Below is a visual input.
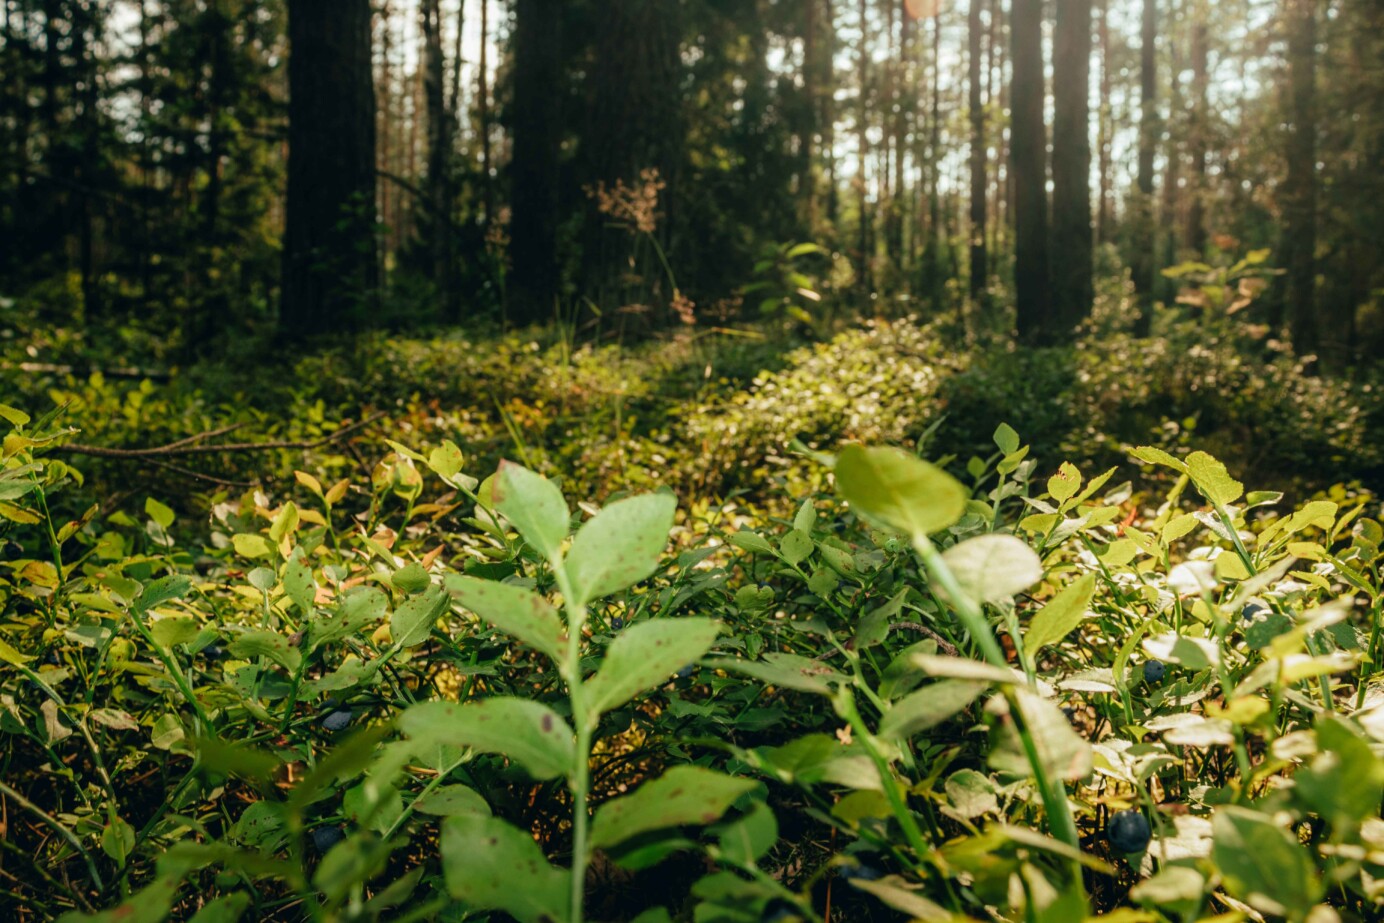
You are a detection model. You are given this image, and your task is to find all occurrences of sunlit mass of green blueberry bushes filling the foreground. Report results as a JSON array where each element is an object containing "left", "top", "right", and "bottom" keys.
[{"left": 0, "top": 398, "right": 1384, "bottom": 923}]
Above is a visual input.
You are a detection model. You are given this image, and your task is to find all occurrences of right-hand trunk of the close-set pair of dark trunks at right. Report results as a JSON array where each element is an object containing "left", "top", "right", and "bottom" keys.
[{"left": 1052, "top": 0, "right": 1092, "bottom": 333}]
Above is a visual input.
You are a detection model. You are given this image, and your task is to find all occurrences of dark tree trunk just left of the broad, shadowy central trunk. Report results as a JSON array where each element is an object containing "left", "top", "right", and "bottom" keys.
[{"left": 507, "top": 0, "right": 563, "bottom": 324}]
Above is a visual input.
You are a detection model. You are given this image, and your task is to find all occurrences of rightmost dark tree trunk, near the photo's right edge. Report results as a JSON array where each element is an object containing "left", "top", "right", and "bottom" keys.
[{"left": 1283, "top": 0, "right": 1322, "bottom": 356}]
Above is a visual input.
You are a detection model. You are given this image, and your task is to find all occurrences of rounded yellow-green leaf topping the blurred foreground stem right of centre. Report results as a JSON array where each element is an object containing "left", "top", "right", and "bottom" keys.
[{"left": 836, "top": 446, "right": 967, "bottom": 537}]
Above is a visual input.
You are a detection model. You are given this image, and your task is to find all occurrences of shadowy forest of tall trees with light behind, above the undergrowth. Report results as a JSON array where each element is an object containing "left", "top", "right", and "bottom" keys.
[{"left": 0, "top": 0, "right": 1384, "bottom": 371}]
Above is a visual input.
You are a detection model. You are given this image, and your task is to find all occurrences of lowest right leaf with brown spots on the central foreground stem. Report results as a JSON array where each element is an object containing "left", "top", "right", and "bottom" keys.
[{"left": 591, "top": 765, "right": 757, "bottom": 848}]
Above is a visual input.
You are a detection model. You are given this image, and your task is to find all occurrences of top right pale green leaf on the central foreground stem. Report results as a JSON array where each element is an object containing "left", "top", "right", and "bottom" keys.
[{"left": 566, "top": 494, "right": 678, "bottom": 606}]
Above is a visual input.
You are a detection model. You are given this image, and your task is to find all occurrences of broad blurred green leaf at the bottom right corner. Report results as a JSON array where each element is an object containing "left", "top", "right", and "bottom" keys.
[{"left": 1211, "top": 805, "right": 1320, "bottom": 920}]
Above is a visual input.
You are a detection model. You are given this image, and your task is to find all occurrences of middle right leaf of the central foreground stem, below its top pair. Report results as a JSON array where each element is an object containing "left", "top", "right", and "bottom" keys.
[{"left": 585, "top": 619, "right": 721, "bottom": 721}]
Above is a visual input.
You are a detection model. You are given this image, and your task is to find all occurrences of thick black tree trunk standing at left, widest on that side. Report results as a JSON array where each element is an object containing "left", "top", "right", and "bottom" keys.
[{"left": 280, "top": 0, "right": 379, "bottom": 338}]
